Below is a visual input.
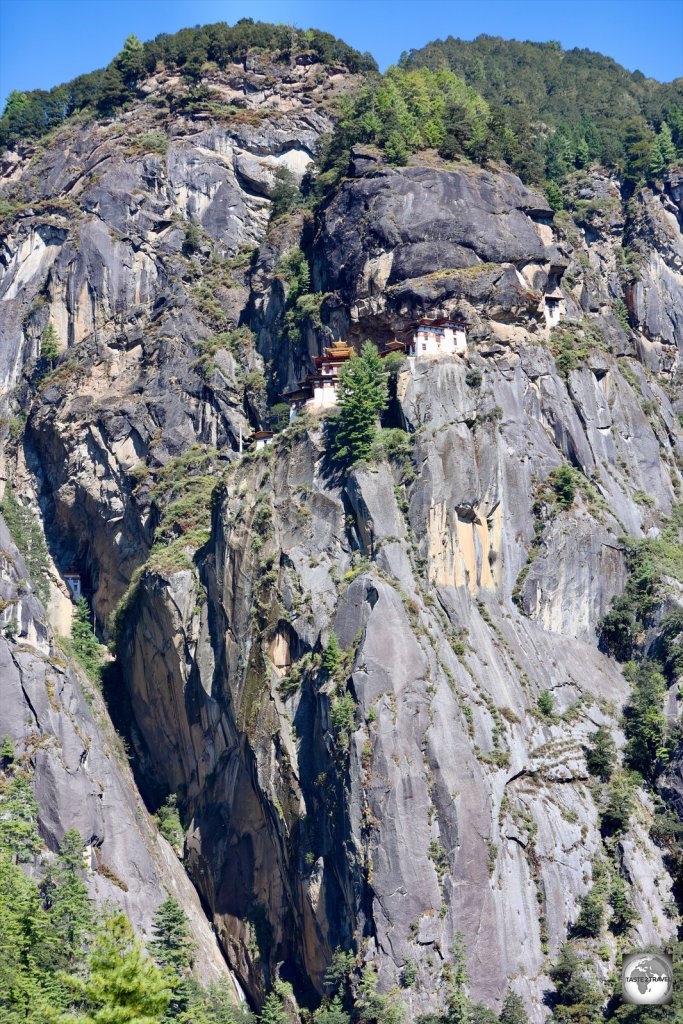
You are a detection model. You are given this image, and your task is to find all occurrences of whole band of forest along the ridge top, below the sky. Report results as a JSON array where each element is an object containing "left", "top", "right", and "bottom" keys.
[{"left": 0, "top": 18, "right": 683, "bottom": 203}]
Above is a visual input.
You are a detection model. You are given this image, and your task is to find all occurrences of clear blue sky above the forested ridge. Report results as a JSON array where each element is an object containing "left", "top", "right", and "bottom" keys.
[{"left": 0, "top": 0, "right": 683, "bottom": 109}]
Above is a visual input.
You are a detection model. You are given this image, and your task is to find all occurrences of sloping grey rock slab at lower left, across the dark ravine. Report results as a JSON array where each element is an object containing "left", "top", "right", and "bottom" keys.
[{"left": 0, "top": 519, "right": 238, "bottom": 1001}]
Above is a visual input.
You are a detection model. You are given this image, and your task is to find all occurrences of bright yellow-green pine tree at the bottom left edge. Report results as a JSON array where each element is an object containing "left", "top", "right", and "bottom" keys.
[{"left": 59, "top": 911, "right": 172, "bottom": 1024}]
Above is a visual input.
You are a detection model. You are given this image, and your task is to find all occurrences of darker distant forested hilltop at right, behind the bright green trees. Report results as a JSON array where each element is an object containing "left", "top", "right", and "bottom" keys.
[{"left": 400, "top": 35, "right": 683, "bottom": 190}]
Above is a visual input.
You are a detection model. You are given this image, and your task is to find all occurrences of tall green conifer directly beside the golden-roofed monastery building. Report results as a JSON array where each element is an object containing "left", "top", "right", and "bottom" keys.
[{"left": 331, "top": 341, "right": 388, "bottom": 466}]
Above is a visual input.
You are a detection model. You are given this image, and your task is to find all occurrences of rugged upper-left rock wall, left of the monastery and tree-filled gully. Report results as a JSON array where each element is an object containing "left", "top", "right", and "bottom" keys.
[{"left": 0, "top": 58, "right": 362, "bottom": 629}]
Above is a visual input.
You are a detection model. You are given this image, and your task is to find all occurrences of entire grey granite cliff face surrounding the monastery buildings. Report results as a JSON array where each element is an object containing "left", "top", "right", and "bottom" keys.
[{"left": 0, "top": 49, "right": 683, "bottom": 1021}]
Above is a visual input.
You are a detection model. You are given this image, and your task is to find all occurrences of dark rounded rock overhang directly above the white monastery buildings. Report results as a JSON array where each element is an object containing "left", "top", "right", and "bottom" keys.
[{"left": 313, "top": 152, "right": 566, "bottom": 350}]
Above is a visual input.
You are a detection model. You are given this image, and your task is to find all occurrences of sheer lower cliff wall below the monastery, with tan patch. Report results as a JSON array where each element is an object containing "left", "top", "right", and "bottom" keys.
[{"left": 120, "top": 350, "right": 673, "bottom": 1019}]
